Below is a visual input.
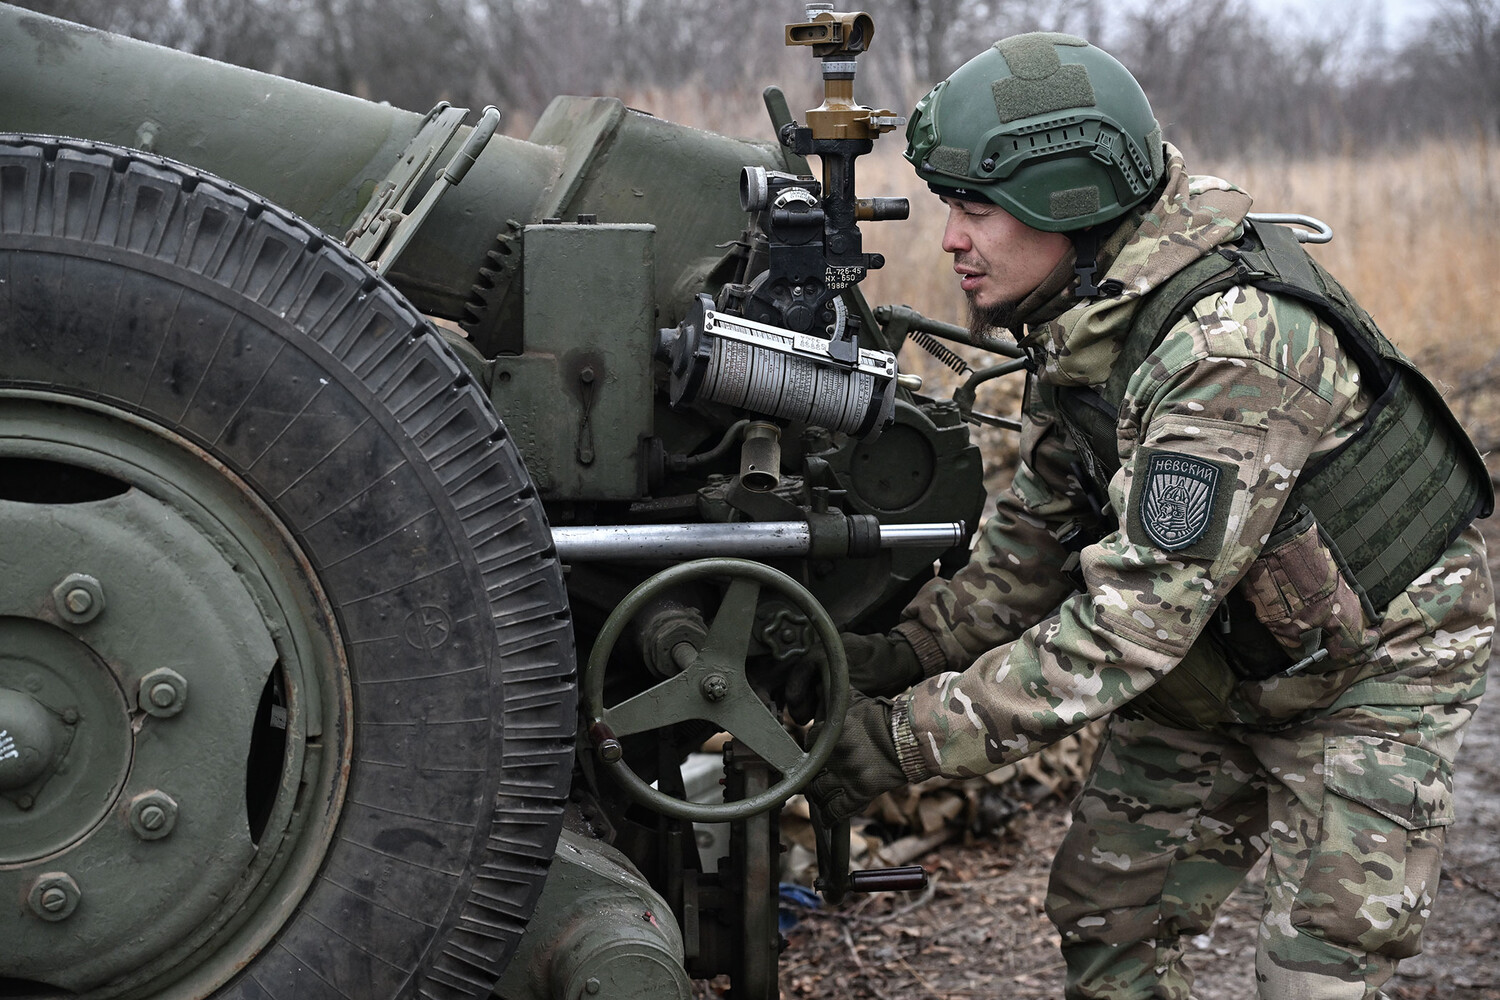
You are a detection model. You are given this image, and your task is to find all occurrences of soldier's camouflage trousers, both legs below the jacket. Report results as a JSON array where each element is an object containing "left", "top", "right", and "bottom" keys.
[{"left": 1047, "top": 702, "right": 1478, "bottom": 1000}]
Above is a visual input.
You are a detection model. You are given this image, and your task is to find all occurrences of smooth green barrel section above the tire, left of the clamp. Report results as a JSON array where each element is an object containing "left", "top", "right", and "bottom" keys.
[{"left": 0, "top": 6, "right": 422, "bottom": 234}]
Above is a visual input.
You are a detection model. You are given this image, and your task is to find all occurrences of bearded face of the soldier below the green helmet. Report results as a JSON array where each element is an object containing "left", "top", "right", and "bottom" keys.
[{"left": 942, "top": 196, "right": 1073, "bottom": 325}]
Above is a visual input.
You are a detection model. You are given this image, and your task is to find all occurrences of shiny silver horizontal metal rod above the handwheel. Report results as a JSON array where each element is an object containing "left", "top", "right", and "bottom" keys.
[{"left": 552, "top": 520, "right": 966, "bottom": 562}]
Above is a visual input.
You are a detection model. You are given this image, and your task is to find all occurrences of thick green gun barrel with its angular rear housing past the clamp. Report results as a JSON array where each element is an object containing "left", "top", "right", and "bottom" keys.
[{"left": 0, "top": 3, "right": 785, "bottom": 324}]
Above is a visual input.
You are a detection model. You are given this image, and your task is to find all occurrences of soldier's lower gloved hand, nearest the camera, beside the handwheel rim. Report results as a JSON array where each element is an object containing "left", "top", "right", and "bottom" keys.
[{"left": 804, "top": 691, "right": 906, "bottom": 825}]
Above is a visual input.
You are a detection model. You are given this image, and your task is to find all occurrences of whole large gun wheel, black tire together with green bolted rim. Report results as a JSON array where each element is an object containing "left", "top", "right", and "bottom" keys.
[{"left": 0, "top": 136, "right": 576, "bottom": 1000}]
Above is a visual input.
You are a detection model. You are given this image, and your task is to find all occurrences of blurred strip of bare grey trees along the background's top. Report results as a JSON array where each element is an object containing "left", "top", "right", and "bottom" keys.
[{"left": 8, "top": 0, "right": 1500, "bottom": 153}]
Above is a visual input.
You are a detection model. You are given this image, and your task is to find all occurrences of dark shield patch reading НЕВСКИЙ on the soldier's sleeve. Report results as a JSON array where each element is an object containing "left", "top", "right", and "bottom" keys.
[{"left": 1128, "top": 448, "right": 1235, "bottom": 555}]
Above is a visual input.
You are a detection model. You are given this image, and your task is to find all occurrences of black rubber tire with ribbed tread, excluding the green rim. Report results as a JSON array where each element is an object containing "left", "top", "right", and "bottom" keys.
[{"left": 0, "top": 135, "right": 576, "bottom": 1000}]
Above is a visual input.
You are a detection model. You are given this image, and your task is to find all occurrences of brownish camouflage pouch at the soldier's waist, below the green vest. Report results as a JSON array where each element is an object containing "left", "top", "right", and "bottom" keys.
[{"left": 1239, "top": 508, "right": 1380, "bottom": 672}]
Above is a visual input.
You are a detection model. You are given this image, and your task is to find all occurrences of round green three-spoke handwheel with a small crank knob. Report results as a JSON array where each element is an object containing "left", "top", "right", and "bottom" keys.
[{"left": 584, "top": 559, "right": 849, "bottom": 823}]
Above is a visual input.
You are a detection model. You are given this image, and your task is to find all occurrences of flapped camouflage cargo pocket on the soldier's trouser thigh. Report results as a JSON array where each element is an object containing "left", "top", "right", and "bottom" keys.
[{"left": 1292, "top": 736, "right": 1454, "bottom": 958}]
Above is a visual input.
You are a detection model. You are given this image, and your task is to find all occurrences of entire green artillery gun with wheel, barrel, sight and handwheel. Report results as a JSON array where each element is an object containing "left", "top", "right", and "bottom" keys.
[{"left": 0, "top": 4, "right": 1020, "bottom": 1000}]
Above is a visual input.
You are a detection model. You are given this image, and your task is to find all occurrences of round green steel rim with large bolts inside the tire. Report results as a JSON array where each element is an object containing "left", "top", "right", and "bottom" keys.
[{"left": 0, "top": 393, "right": 351, "bottom": 1000}]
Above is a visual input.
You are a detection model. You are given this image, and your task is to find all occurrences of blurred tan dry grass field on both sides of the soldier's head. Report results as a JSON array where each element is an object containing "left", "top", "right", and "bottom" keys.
[{"left": 861, "top": 139, "right": 1500, "bottom": 395}]
